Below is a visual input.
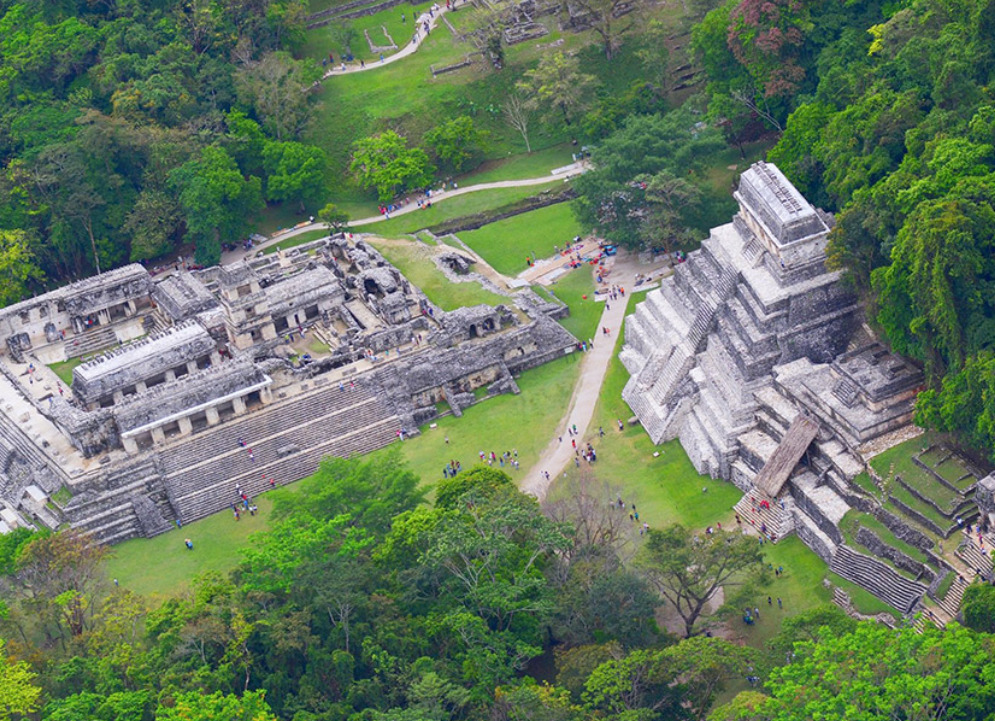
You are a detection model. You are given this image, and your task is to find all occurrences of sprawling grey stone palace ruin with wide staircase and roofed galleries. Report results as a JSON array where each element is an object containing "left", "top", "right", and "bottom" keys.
[{"left": 0, "top": 236, "right": 576, "bottom": 542}]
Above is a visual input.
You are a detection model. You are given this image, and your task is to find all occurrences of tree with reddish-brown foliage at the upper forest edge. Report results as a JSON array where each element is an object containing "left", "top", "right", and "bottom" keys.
[{"left": 727, "top": 0, "right": 810, "bottom": 99}]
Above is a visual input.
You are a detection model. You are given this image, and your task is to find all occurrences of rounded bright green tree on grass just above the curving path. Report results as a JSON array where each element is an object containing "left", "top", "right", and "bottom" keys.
[{"left": 349, "top": 130, "right": 435, "bottom": 202}]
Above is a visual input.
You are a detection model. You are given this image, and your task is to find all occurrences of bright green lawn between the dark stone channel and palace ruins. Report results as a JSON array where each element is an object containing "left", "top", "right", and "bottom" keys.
[{"left": 457, "top": 202, "right": 583, "bottom": 276}]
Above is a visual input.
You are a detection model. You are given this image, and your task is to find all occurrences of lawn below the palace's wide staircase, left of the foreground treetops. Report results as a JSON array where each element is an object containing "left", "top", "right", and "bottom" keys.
[{"left": 106, "top": 493, "right": 273, "bottom": 596}]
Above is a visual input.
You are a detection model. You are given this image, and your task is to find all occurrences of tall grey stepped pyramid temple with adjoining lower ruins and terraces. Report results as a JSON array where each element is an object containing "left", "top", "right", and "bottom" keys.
[{"left": 621, "top": 162, "right": 995, "bottom": 612}]
